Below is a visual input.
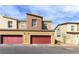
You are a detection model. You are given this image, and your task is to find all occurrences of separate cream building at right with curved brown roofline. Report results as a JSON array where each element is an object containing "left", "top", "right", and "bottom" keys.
[{"left": 54, "top": 22, "right": 79, "bottom": 44}]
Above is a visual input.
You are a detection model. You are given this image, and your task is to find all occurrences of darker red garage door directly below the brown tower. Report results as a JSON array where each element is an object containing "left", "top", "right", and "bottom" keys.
[{"left": 31, "top": 36, "right": 51, "bottom": 44}]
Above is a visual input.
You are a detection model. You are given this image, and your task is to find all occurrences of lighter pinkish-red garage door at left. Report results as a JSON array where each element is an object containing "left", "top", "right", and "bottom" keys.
[{"left": 2, "top": 35, "right": 22, "bottom": 44}]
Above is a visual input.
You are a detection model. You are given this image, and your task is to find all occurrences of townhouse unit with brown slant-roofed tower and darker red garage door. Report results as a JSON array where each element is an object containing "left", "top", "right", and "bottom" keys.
[{"left": 23, "top": 13, "right": 54, "bottom": 44}]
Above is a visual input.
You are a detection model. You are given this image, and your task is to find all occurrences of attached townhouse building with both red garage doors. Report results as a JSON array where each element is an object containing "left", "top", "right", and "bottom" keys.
[{"left": 0, "top": 13, "right": 55, "bottom": 45}]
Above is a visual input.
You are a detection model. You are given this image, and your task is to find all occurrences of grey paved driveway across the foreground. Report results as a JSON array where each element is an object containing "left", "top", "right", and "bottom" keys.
[{"left": 0, "top": 45, "right": 79, "bottom": 54}]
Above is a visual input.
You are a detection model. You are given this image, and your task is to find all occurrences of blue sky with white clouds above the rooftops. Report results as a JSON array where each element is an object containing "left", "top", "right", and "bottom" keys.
[{"left": 0, "top": 5, "right": 79, "bottom": 28}]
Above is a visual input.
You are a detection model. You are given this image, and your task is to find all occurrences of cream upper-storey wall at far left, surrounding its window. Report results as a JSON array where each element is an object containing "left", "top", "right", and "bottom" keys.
[{"left": 0, "top": 16, "right": 17, "bottom": 29}]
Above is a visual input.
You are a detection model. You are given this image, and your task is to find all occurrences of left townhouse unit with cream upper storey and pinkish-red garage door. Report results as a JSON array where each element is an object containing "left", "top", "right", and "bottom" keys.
[{"left": 0, "top": 15, "right": 22, "bottom": 44}]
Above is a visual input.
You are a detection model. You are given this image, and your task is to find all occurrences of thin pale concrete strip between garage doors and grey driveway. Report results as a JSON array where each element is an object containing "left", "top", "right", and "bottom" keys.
[{"left": 0, "top": 44, "right": 79, "bottom": 48}]
